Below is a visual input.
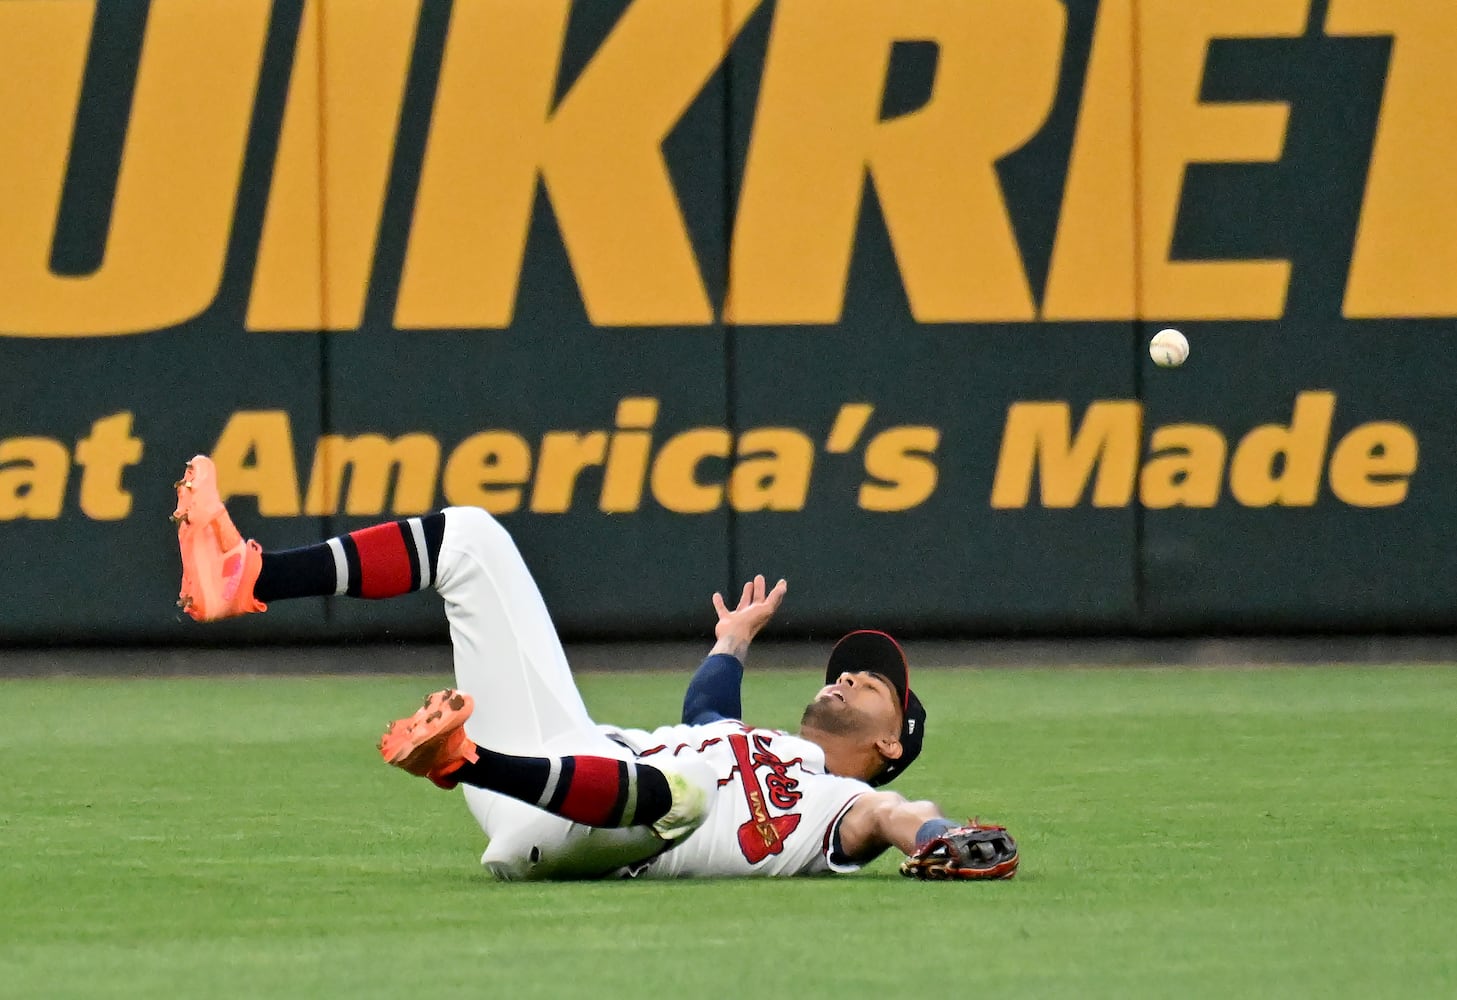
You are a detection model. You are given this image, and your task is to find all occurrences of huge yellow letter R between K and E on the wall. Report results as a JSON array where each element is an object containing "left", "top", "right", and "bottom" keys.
[{"left": 724, "top": 0, "right": 1067, "bottom": 324}]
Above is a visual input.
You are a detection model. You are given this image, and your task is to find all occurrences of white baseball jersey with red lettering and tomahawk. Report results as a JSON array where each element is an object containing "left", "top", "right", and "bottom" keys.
[{"left": 606, "top": 720, "right": 871, "bottom": 879}]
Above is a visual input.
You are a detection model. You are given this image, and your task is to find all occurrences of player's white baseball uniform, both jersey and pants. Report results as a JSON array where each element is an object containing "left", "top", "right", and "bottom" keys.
[{"left": 422, "top": 507, "right": 870, "bottom": 879}]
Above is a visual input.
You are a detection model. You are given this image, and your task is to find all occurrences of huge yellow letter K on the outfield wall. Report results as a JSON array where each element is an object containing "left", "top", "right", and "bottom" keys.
[{"left": 395, "top": 0, "right": 759, "bottom": 329}]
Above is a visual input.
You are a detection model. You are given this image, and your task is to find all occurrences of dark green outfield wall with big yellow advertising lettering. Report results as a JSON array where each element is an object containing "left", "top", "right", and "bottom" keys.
[{"left": 0, "top": 0, "right": 1457, "bottom": 643}]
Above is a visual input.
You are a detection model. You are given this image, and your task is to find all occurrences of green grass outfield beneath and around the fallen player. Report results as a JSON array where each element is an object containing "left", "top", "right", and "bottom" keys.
[{"left": 0, "top": 668, "right": 1457, "bottom": 999}]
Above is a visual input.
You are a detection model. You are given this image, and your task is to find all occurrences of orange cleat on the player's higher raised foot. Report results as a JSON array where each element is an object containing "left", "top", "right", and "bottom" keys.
[{"left": 172, "top": 455, "right": 268, "bottom": 621}]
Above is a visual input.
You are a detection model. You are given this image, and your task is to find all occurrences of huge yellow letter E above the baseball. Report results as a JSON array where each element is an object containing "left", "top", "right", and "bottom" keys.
[{"left": 1043, "top": 0, "right": 1310, "bottom": 319}]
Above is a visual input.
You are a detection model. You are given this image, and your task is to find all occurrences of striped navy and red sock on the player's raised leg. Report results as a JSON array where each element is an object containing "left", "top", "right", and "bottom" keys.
[{"left": 254, "top": 513, "right": 446, "bottom": 602}]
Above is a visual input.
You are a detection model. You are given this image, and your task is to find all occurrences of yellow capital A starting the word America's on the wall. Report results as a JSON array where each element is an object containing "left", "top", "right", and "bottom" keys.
[{"left": 208, "top": 410, "right": 299, "bottom": 517}]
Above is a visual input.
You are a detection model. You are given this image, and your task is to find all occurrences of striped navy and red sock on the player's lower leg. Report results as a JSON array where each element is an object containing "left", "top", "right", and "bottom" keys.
[{"left": 450, "top": 746, "right": 673, "bottom": 827}]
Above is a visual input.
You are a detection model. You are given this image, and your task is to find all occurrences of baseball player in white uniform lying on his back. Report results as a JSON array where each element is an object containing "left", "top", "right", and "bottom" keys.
[{"left": 173, "top": 455, "right": 1017, "bottom": 879}]
